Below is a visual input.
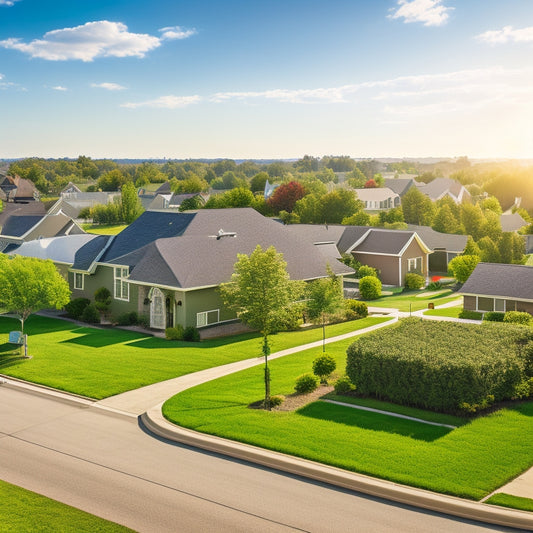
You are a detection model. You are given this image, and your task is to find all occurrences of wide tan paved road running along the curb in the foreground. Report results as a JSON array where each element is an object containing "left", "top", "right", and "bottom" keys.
[{"left": 0, "top": 385, "right": 508, "bottom": 533}]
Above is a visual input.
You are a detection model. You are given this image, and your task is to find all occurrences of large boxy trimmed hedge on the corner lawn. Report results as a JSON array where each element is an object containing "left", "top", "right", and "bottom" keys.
[{"left": 346, "top": 318, "right": 533, "bottom": 413}]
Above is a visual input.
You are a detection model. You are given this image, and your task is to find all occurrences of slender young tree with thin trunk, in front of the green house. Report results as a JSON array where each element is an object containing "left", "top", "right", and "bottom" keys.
[{"left": 219, "top": 245, "right": 303, "bottom": 410}]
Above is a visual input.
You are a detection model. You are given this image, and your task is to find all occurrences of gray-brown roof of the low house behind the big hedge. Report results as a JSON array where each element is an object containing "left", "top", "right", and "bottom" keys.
[{"left": 459, "top": 263, "right": 533, "bottom": 301}]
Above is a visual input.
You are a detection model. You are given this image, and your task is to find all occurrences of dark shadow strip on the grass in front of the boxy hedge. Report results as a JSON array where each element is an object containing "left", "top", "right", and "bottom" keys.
[{"left": 296, "top": 402, "right": 453, "bottom": 442}]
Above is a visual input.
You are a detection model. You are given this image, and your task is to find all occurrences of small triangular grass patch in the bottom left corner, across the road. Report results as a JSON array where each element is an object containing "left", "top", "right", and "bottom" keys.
[{"left": 0, "top": 480, "right": 132, "bottom": 533}]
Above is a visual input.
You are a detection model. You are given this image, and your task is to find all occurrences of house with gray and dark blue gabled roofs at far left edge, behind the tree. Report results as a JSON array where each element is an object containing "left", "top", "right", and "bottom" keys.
[{"left": 0, "top": 202, "right": 85, "bottom": 252}]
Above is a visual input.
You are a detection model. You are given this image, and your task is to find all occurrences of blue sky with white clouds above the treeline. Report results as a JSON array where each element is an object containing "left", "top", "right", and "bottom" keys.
[{"left": 0, "top": 0, "right": 533, "bottom": 159}]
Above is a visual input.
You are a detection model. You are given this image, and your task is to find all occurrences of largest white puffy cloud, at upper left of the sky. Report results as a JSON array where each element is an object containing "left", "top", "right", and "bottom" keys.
[{"left": 0, "top": 20, "right": 194, "bottom": 61}]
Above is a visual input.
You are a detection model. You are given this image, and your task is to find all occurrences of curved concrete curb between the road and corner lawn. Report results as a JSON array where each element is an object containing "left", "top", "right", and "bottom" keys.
[{"left": 140, "top": 403, "right": 533, "bottom": 531}]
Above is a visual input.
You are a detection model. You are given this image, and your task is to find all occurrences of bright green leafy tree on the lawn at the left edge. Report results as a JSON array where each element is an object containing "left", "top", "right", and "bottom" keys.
[{"left": 0, "top": 254, "right": 70, "bottom": 355}]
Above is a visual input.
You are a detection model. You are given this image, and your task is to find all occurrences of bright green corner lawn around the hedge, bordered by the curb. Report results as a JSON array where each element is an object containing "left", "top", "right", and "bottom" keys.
[{"left": 163, "top": 332, "right": 533, "bottom": 499}]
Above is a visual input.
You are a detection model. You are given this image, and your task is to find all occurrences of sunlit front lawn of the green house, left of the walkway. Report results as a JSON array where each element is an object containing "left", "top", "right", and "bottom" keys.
[{"left": 0, "top": 316, "right": 390, "bottom": 399}]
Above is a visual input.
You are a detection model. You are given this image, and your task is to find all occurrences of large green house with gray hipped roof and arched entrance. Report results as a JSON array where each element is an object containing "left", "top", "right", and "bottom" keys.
[{"left": 10, "top": 208, "right": 353, "bottom": 329}]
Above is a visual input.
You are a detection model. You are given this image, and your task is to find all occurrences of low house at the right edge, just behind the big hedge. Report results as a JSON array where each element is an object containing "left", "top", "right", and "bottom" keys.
[{"left": 459, "top": 263, "right": 533, "bottom": 314}]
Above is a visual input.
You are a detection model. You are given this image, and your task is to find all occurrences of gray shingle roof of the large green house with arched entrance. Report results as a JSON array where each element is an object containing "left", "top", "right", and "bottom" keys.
[{"left": 102, "top": 208, "right": 353, "bottom": 289}]
